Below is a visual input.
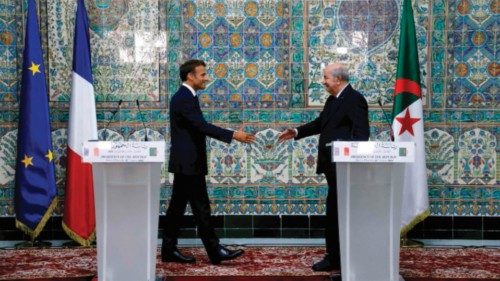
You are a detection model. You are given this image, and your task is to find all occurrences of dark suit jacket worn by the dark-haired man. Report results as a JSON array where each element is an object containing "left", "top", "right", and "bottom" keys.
[{"left": 168, "top": 86, "right": 233, "bottom": 175}]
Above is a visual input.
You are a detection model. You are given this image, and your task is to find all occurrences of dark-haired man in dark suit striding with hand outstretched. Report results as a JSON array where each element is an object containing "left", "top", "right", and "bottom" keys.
[{"left": 161, "top": 60, "right": 255, "bottom": 264}]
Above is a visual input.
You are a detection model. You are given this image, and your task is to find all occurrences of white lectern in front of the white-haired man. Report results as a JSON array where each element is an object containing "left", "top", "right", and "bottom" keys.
[{"left": 331, "top": 142, "right": 415, "bottom": 281}]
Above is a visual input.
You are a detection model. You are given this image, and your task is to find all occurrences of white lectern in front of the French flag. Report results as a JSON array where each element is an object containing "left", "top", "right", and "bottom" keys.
[{"left": 83, "top": 141, "right": 165, "bottom": 281}]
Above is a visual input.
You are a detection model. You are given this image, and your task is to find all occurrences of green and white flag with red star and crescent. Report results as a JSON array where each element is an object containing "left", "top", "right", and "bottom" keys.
[{"left": 392, "top": 0, "right": 429, "bottom": 235}]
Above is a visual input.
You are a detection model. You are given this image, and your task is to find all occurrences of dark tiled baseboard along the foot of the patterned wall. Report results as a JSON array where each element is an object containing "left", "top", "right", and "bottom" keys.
[{"left": 0, "top": 215, "right": 500, "bottom": 240}]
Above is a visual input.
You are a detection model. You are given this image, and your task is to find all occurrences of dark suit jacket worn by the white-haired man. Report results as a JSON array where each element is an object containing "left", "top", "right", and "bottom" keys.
[{"left": 295, "top": 84, "right": 370, "bottom": 174}]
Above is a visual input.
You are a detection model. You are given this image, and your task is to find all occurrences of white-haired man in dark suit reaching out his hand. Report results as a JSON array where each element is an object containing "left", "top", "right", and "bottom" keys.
[{"left": 278, "top": 63, "right": 370, "bottom": 271}]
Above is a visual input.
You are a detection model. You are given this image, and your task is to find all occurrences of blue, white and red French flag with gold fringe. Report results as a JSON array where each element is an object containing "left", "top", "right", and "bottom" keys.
[{"left": 62, "top": 0, "right": 97, "bottom": 246}]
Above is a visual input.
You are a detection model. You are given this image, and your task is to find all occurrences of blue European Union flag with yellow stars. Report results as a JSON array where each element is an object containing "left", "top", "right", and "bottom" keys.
[{"left": 14, "top": 0, "right": 57, "bottom": 241}]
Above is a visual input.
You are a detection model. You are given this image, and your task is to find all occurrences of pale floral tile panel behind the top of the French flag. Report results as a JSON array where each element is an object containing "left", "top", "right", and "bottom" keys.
[{"left": 47, "top": 0, "right": 160, "bottom": 102}]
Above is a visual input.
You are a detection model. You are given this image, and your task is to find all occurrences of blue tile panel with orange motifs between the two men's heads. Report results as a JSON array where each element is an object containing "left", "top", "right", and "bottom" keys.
[{"left": 169, "top": 0, "right": 302, "bottom": 109}]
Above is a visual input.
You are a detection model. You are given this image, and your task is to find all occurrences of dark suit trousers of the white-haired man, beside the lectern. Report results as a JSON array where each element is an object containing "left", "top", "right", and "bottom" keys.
[{"left": 324, "top": 163, "right": 340, "bottom": 261}]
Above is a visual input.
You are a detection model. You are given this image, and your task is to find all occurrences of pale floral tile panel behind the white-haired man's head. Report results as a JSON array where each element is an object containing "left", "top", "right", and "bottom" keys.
[{"left": 306, "top": 0, "right": 431, "bottom": 106}]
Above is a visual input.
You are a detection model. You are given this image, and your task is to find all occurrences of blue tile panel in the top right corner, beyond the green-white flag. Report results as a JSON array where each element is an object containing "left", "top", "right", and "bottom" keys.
[{"left": 446, "top": 1, "right": 499, "bottom": 109}]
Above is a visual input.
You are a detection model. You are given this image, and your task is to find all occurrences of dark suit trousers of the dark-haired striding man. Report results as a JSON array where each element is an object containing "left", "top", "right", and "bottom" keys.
[{"left": 163, "top": 174, "right": 219, "bottom": 252}]
